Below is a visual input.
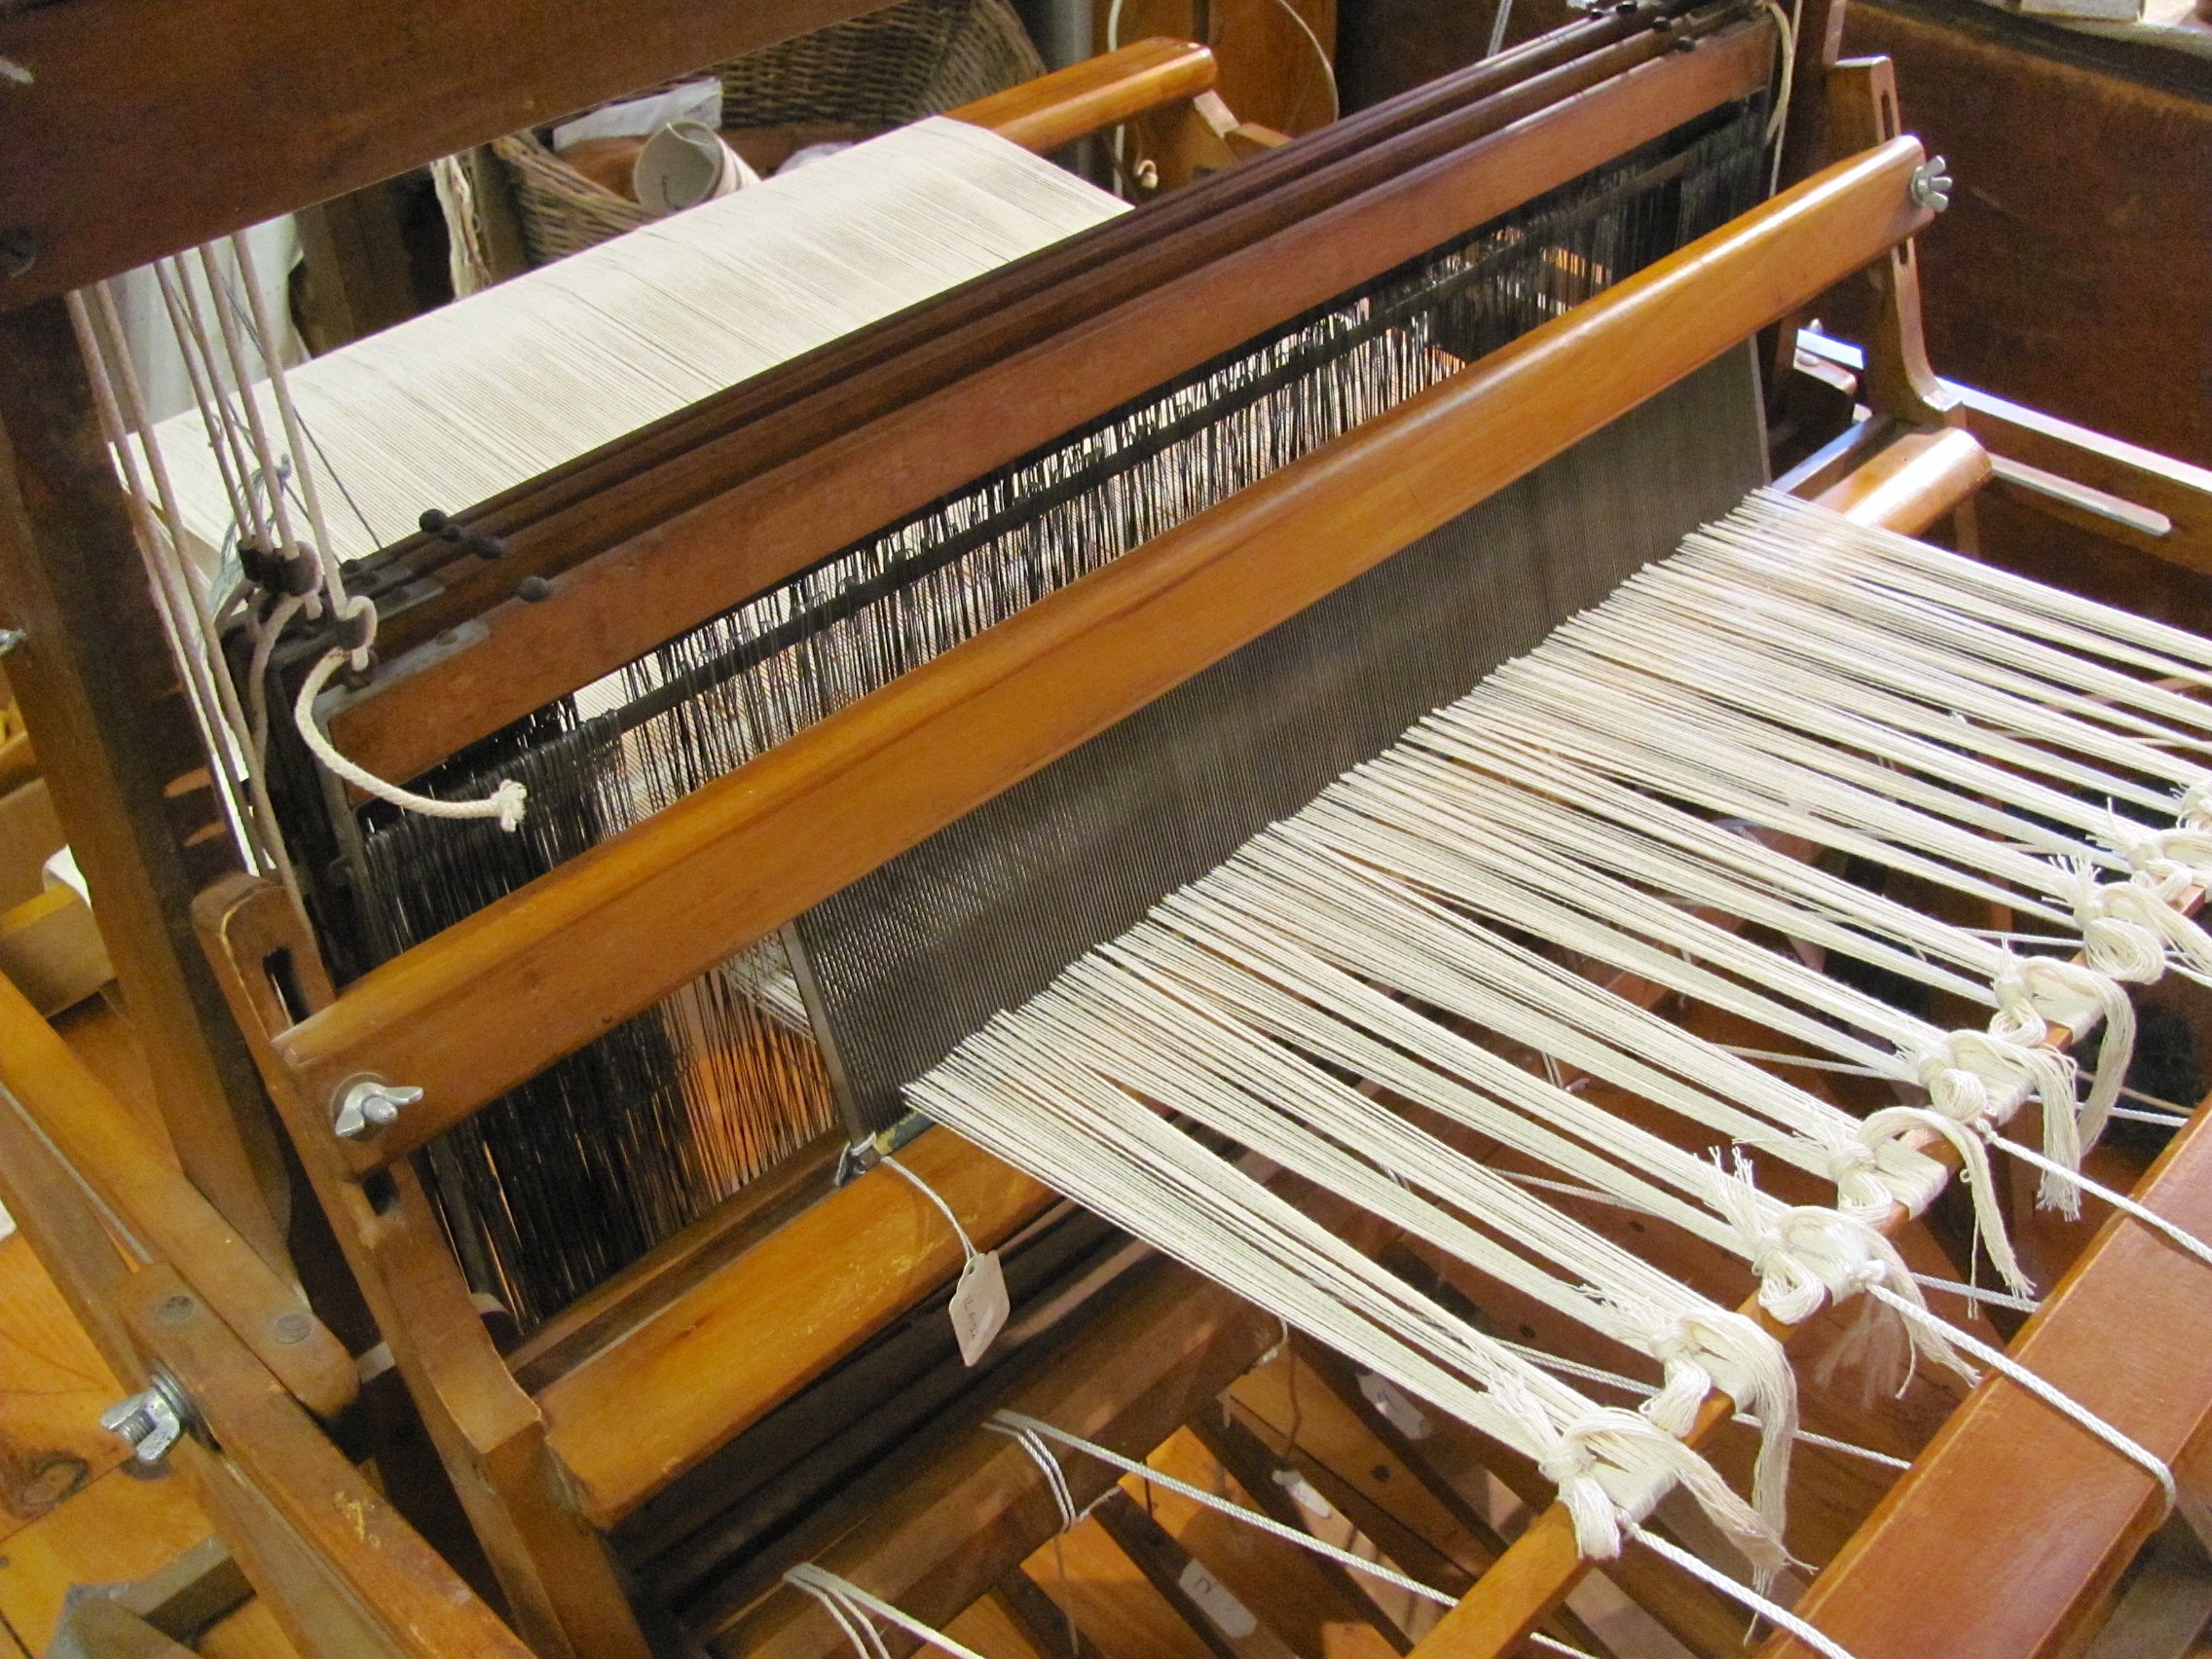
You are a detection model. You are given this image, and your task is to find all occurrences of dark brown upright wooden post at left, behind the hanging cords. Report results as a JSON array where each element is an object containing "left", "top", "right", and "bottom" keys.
[{"left": 0, "top": 299, "right": 290, "bottom": 1274}]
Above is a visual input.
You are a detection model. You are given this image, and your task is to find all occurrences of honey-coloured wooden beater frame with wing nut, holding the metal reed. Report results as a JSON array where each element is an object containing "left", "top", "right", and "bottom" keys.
[{"left": 185, "top": 123, "right": 1955, "bottom": 1652}]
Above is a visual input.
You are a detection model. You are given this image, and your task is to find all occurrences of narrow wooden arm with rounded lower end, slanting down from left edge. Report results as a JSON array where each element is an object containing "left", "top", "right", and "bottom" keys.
[{"left": 0, "top": 979, "right": 356, "bottom": 1418}]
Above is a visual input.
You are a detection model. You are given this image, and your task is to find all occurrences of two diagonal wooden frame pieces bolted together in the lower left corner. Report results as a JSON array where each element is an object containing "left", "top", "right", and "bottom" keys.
[{"left": 0, "top": 979, "right": 531, "bottom": 1659}]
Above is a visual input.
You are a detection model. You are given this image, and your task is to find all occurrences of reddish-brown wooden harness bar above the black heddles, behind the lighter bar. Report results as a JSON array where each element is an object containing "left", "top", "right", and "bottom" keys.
[{"left": 327, "top": 22, "right": 1772, "bottom": 779}]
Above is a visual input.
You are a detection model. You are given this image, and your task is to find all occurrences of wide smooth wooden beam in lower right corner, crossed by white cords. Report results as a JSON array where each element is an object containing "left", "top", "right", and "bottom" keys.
[{"left": 1758, "top": 1111, "right": 2212, "bottom": 1659}]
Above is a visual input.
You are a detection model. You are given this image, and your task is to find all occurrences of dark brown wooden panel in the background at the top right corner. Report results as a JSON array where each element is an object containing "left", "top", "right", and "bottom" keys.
[{"left": 1845, "top": 2, "right": 2212, "bottom": 464}]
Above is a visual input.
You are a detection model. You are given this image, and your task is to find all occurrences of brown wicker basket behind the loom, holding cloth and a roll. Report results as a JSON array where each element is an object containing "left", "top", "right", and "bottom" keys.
[{"left": 477, "top": 0, "right": 1044, "bottom": 266}]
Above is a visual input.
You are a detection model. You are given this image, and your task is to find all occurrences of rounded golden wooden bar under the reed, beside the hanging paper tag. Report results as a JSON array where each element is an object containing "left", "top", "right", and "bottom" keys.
[{"left": 537, "top": 1130, "right": 1055, "bottom": 1527}]
